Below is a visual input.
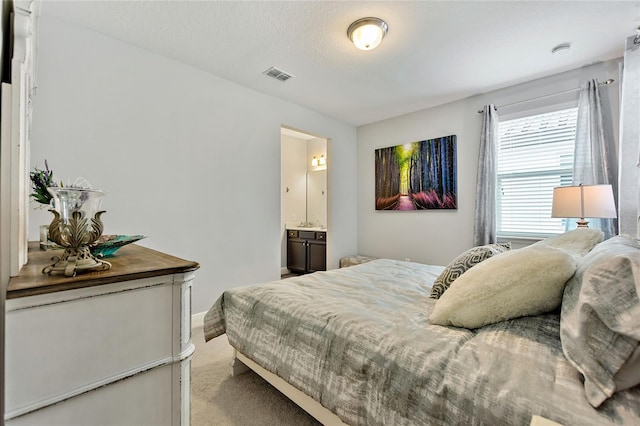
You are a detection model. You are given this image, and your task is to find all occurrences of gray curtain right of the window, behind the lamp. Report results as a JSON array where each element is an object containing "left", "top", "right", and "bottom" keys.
[{"left": 573, "top": 79, "right": 618, "bottom": 238}]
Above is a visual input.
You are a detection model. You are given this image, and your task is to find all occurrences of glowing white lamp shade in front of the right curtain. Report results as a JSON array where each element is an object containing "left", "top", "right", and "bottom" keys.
[{"left": 551, "top": 185, "right": 617, "bottom": 218}]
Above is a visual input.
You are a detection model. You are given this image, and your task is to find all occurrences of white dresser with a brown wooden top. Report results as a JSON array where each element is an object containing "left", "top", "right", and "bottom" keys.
[{"left": 5, "top": 244, "right": 199, "bottom": 426}]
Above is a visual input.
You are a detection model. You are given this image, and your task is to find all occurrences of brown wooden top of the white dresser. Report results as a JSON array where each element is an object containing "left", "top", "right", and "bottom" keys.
[{"left": 7, "top": 241, "right": 200, "bottom": 299}]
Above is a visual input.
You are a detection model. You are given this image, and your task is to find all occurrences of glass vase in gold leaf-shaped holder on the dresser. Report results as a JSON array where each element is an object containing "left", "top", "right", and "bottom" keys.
[{"left": 42, "top": 187, "right": 111, "bottom": 277}]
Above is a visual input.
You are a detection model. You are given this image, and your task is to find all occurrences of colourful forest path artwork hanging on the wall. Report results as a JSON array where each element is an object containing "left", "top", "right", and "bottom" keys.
[{"left": 375, "top": 135, "right": 458, "bottom": 210}]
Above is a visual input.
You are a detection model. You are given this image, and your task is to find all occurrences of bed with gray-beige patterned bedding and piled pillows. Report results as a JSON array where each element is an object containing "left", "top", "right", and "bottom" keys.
[{"left": 204, "top": 231, "right": 640, "bottom": 425}]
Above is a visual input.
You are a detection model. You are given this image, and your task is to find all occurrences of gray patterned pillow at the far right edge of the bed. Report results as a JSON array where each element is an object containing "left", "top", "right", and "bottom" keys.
[{"left": 560, "top": 235, "right": 640, "bottom": 407}]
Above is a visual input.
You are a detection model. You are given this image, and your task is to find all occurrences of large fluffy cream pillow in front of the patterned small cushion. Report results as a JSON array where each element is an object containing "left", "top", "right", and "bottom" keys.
[{"left": 429, "top": 245, "right": 577, "bottom": 328}]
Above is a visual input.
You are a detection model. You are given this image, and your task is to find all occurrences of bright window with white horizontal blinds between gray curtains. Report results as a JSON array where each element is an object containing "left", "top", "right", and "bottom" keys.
[{"left": 496, "top": 107, "right": 578, "bottom": 238}]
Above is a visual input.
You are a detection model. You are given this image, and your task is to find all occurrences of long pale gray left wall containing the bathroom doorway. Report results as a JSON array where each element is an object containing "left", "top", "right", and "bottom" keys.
[{"left": 29, "top": 16, "right": 357, "bottom": 313}]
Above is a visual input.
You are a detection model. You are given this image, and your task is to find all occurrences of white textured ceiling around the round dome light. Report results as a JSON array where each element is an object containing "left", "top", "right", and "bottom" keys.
[{"left": 40, "top": 0, "right": 640, "bottom": 125}]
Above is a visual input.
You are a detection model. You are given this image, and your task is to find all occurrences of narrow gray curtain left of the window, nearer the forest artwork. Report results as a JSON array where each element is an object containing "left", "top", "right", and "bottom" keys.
[{"left": 473, "top": 105, "right": 499, "bottom": 246}]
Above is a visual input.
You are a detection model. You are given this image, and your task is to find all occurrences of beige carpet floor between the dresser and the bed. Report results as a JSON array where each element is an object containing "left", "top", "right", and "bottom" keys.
[{"left": 191, "top": 327, "right": 320, "bottom": 426}]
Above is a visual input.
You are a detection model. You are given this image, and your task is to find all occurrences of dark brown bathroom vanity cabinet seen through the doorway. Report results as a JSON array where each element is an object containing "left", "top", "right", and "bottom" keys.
[{"left": 287, "top": 229, "right": 327, "bottom": 274}]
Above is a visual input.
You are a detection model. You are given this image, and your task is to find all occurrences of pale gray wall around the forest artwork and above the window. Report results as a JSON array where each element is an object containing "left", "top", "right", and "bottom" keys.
[{"left": 358, "top": 61, "right": 619, "bottom": 265}]
